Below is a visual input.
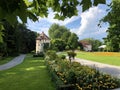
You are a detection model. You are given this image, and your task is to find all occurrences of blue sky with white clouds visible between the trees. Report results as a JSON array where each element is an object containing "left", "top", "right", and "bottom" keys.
[{"left": 27, "top": 0, "right": 111, "bottom": 40}]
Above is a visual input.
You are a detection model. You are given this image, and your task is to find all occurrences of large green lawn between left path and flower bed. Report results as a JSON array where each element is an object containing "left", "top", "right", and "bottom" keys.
[{"left": 0, "top": 55, "right": 55, "bottom": 90}]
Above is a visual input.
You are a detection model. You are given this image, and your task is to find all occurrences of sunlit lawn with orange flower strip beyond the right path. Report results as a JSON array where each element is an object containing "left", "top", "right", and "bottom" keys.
[{"left": 76, "top": 52, "right": 120, "bottom": 66}]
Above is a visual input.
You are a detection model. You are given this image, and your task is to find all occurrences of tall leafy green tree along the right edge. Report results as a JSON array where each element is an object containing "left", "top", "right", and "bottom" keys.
[{"left": 103, "top": 0, "right": 120, "bottom": 52}]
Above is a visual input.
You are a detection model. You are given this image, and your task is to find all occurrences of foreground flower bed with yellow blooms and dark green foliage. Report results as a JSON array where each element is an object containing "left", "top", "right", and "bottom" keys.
[{"left": 46, "top": 60, "right": 120, "bottom": 90}]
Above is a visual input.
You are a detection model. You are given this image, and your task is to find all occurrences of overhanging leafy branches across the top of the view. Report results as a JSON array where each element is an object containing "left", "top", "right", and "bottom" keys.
[{"left": 0, "top": 0, "right": 106, "bottom": 24}]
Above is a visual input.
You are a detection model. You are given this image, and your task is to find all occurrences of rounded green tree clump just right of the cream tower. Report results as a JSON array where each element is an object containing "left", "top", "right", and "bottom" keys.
[{"left": 49, "top": 24, "right": 78, "bottom": 51}]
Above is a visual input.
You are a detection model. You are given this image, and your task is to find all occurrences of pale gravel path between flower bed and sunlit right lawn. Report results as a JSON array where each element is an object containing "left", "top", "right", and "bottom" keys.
[{"left": 74, "top": 58, "right": 120, "bottom": 79}]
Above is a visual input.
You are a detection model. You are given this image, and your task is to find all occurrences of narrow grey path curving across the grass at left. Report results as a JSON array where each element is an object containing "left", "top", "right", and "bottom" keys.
[{"left": 0, "top": 54, "right": 26, "bottom": 70}]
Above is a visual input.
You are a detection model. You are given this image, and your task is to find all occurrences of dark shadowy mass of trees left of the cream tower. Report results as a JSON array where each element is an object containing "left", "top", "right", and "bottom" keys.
[{"left": 0, "top": 21, "right": 37, "bottom": 56}]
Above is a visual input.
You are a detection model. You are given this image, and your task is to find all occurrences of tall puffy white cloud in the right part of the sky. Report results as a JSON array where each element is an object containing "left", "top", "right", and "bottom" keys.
[{"left": 77, "top": 7, "right": 107, "bottom": 38}]
